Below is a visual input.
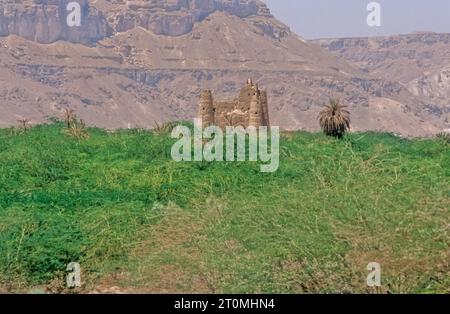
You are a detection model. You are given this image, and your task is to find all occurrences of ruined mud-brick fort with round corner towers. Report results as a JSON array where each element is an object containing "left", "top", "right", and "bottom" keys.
[{"left": 199, "top": 79, "right": 270, "bottom": 129}]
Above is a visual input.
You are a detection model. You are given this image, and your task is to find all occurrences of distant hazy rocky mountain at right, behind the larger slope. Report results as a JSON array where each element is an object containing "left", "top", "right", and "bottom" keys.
[{"left": 314, "top": 33, "right": 450, "bottom": 132}]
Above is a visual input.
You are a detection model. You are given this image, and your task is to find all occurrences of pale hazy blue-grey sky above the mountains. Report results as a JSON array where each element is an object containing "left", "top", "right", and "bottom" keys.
[{"left": 264, "top": 0, "right": 450, "bottom": 39}]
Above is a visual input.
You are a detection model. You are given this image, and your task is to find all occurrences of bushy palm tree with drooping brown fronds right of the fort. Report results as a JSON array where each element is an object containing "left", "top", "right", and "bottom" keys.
[{"left": 318, "top": 99, "right": 350, "bottom": 138}]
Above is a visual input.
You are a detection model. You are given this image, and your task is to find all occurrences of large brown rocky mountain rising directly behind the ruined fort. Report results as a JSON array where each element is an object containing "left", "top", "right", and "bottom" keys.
[{"left": 0, "top": 0, "right": 445, "bottom": 136}]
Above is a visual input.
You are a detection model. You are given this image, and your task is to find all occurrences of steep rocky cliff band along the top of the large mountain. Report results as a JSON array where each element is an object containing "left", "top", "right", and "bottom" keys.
[{"left": 0, "top": 0, "right": 288, "bottom": 44}]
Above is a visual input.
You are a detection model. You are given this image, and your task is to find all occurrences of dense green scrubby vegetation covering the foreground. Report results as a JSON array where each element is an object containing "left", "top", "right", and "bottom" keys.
[{"left": 0, "top": 123, "right": 450, "bottom": 293}]
